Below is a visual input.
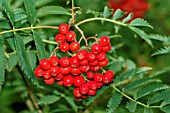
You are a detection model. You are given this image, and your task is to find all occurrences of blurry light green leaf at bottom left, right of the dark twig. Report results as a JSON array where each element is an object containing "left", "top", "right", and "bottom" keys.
[{"left": 38, "top": 95, "right": 60, "bottom": 104}]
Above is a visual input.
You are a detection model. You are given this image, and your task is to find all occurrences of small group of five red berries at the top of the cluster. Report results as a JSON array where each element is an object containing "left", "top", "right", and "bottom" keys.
[{"left": 55, "top": 24, "right": 80, "bottom": 52}]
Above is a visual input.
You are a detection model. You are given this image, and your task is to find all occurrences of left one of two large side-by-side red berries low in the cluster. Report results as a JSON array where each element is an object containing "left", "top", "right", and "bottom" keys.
[{"left": 63, "top": 75, "right": 73, "bottom": 87}]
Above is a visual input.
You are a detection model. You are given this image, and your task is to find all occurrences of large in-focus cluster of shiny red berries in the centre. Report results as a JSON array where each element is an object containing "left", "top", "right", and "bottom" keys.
[{"left": 34, "top": 24, "right": 114, "bottom": 99}]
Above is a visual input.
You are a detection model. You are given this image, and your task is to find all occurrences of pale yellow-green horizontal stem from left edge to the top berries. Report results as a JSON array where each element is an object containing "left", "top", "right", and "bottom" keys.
[{"left": 0, "top": 26, "right": 58, "bottom": 35}]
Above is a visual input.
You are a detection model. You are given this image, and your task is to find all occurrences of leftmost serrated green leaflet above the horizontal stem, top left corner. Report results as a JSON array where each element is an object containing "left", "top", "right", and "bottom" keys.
[{"left": 2, "top": 0, "right": 15, "bottom": 26}]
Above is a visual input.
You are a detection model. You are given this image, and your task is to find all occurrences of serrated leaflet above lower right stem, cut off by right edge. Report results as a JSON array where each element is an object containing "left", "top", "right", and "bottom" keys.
[{"left": 148, "top": 90, "right": 170, "bottom": 104}]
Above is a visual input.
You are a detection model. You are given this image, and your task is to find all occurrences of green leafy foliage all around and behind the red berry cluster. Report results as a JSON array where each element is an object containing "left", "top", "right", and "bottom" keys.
[{"left": 0, "top": 0, "right": 170, "bottom": 113}]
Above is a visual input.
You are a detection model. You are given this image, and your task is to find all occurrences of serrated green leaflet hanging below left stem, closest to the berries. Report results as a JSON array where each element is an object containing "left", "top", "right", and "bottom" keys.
[{"left": 33, "top": 31, "right": 47, "bottom": 60}]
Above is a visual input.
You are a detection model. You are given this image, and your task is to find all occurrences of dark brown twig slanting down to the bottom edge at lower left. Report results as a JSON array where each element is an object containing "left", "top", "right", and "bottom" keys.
[{"left": 16, "top": 65, "right": 42, "bottom": 113}]
